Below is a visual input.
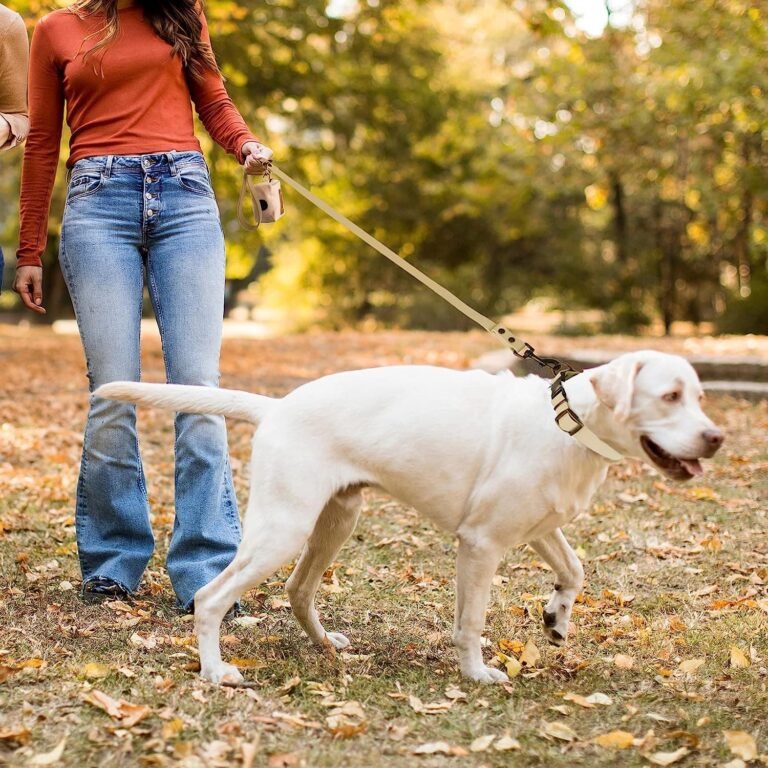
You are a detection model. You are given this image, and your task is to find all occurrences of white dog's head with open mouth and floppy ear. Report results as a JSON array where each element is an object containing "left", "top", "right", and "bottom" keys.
[{"left": 588, "top": 352, "right": 724, "bottom": 480}]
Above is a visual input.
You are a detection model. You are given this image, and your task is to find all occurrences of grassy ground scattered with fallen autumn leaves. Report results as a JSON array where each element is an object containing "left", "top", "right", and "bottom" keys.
[{"left": 0, "top": 326, "right": 768, "bottom": 768}]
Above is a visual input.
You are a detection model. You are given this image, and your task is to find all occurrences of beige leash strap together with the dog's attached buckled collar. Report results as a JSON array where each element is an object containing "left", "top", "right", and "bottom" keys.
[{"left": 268, "top": 165, "right": 623, "bottom": 461}]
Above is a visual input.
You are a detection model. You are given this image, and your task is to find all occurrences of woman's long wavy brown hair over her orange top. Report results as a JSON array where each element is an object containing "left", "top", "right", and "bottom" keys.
[{"left": 69, "top": 0, "right": 218, "bottom": 78}]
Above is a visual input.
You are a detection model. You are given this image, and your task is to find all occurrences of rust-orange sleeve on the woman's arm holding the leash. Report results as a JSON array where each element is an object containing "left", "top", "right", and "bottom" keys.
[{"left": 187, "top": 13, "right": 259, "bottom": 163}]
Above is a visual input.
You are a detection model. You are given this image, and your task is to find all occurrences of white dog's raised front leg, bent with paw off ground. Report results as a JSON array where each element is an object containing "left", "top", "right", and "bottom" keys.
[{"left": 530, "top": 528, "right": 584, "bottom": 645}]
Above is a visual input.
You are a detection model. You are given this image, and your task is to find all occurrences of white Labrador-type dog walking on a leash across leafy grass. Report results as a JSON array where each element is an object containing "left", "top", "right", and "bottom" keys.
[{"left": 94, "top": 352, "right": 723, "bottom": 684}]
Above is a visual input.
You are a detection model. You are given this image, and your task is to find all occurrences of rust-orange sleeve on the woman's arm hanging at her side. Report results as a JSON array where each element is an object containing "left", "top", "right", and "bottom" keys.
[{"left": 17, "top": 19, "right": 64, "bottom": 267}]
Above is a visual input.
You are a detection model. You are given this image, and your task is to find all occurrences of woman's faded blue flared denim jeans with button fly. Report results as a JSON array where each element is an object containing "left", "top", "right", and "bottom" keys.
[{"left": 59, "top": 152, "right": 240, "bottom": 607}]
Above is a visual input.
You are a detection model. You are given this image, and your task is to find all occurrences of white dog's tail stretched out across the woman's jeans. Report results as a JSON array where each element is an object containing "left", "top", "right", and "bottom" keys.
[{"left": 93, "top": 381, "right": 275, "bottom": 424}]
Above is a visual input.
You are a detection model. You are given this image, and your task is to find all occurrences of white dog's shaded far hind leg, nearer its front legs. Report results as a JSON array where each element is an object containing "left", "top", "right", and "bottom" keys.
[{"left": 285, "top": 487, "right": 362, "bottom": 649}]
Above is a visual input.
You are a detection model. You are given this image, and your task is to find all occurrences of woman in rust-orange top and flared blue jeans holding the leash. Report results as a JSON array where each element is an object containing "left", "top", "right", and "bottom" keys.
[{"left": 15, "top": 0, "right": 272, "bottom": 610}]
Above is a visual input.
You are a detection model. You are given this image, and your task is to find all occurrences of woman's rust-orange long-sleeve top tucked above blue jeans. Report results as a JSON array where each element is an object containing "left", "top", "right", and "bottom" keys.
[{"left": 17, "top": 6, "right": 258, "bottom": 266}]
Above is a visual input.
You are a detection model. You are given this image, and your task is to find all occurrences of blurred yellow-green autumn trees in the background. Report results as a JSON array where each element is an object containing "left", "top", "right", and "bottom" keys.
[{"left": 0, "top": 0, "right": 768, "bottom": 333}]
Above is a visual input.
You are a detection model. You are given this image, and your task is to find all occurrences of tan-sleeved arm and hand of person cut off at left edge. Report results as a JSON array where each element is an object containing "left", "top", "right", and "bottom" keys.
[{"left": 0, "top": 14, "right": 29, "bottom": 151}]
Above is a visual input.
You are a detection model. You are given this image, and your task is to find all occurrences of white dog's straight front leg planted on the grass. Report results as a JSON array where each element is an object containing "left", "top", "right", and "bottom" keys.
[{"left": 453, "top": 536, "right": 509, "bottom": 683}]
